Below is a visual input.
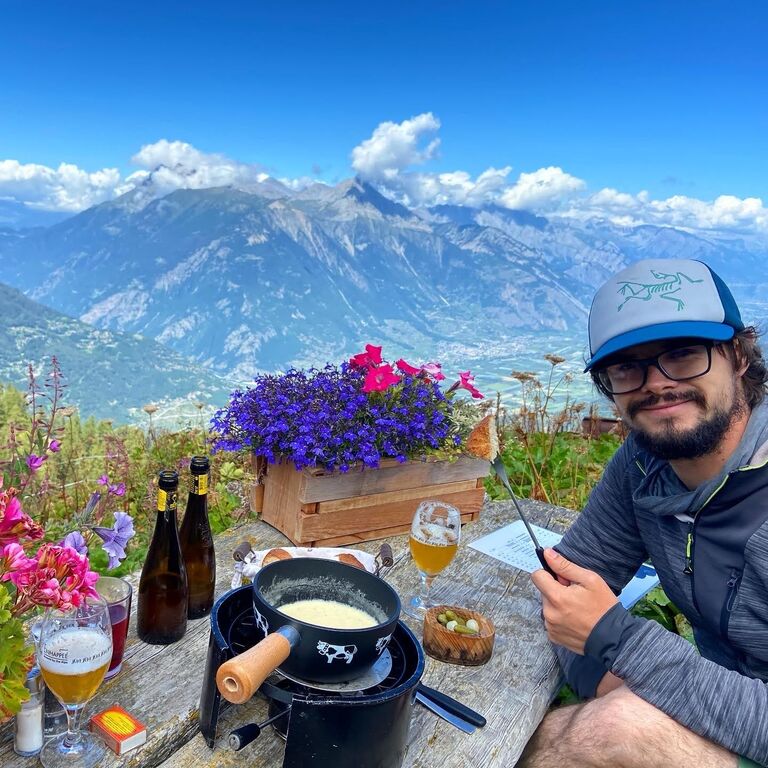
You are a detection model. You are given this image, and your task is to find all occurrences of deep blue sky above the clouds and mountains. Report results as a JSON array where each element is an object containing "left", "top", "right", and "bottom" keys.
[{"left": 0, "top": 0, "right": 768, "bottom": 226}]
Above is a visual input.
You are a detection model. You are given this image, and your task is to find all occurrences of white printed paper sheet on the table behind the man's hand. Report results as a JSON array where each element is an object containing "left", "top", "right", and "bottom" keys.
[{"left": 469, "top": 520, "right": 659, "bottom": 608}]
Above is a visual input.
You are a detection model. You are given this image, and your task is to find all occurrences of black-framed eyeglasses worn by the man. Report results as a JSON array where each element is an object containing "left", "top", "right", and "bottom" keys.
[{"left": 596, "top": 343, "right": 713, "bottom": 395}]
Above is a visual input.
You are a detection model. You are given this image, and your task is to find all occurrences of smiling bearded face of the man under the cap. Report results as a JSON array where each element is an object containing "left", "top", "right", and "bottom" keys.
[{"left": 614, "top": 339, "right": 746, "bottom": 460}]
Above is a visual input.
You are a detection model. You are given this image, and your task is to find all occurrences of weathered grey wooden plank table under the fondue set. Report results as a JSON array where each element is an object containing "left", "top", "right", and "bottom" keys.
[{"left": 0, "top": 501, "right": 575, "bottom": 768}]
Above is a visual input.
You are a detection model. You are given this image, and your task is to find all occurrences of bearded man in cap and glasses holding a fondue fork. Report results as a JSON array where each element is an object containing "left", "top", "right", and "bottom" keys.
[{"left": 519, "top": 259, "right": 768, "bottom": 768}]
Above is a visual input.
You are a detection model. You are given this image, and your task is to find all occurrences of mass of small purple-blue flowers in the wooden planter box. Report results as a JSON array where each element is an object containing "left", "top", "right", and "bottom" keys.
[{"left": 207, "top": 354, "right": 464, "bottom": 472}]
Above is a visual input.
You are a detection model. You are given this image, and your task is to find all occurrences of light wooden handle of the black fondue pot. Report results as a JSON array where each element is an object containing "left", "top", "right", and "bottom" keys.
[{"left": 216, "top": 625, "right": 299, "bottom": 704}]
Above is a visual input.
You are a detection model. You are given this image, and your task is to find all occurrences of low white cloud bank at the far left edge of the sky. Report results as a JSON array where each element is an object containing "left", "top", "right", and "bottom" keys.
[{"left": 0, "top": 160, "right": 120, "bottom": 212}]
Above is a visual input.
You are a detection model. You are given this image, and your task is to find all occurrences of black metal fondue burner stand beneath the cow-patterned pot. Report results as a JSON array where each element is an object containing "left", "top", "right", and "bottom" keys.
[{"left": 200, "top": 585, "right": 424, "bottom": 768}]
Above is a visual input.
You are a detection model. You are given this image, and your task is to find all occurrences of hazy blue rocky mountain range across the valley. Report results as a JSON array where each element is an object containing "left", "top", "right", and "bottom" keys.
[{"left": 0, "top": 176, "right": 768, "bottom": 424}]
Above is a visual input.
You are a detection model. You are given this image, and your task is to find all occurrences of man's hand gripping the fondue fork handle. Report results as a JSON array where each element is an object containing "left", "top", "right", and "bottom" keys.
[{"left": 531, "top": 549, "right": 618, "bottom": 655}]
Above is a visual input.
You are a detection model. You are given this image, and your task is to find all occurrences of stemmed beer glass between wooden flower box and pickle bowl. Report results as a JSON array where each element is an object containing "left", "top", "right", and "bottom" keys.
[{"left": 403, "top": 501, "right": 461, "bottom": 619}]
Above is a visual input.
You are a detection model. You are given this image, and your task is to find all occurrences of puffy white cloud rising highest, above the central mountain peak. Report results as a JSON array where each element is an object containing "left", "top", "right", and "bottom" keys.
[{"left": 352, "top": 112, "right": 440, "bottom": 181}]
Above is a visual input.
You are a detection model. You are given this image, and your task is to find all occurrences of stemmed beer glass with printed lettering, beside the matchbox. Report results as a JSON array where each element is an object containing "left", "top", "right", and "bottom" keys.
[{"left": 37, "top": 598, "right": 112, "bottom": 768}]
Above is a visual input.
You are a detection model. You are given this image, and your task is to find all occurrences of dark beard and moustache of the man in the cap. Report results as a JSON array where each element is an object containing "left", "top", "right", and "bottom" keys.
[{"left": 627, "top": 390, "right": 746, "bottom": 461}]
